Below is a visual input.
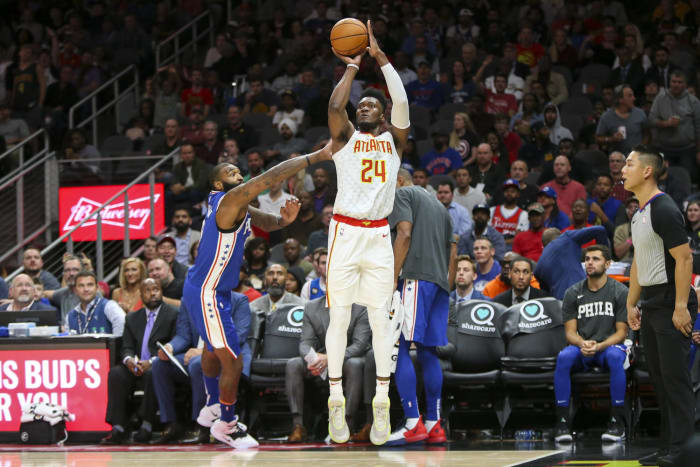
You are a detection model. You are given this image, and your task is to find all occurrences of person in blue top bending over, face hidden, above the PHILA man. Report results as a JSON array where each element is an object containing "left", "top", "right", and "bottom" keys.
[{"left": 535, "top": 225, "right": 608, "bottom": 300}]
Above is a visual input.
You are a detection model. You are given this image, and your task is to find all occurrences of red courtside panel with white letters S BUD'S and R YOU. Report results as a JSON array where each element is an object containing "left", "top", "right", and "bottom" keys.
[{"left": 0, "top": 349, "right": 111, "bottom": 431}]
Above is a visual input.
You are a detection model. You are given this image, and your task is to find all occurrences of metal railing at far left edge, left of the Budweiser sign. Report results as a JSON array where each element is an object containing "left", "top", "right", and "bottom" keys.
[{"left": 0, "top": 129, "right": 55, "bottom": 263}]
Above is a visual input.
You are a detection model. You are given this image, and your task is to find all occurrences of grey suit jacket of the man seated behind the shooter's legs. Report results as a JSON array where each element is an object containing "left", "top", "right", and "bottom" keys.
[{"left": 299, "top": 297, "right": 372, "bottom": 358}]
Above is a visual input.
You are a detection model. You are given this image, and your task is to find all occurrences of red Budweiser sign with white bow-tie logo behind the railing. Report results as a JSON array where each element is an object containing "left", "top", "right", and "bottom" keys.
[{"left": 58, "top": 183, "right": 165, "bottom": 241}]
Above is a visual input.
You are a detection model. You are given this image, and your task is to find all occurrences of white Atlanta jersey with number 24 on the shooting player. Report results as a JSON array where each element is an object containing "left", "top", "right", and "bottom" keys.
[{"left": 333, "top": 131, "right": 401, "bottom": 220}]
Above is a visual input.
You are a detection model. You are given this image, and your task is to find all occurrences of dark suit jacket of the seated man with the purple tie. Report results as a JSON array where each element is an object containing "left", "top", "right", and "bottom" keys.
[{"left": 119, "top": 302, "right": 177, "bottom": 361}]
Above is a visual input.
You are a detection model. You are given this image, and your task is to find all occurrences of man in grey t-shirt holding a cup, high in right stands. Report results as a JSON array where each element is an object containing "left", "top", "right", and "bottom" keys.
[{"left": 596, "top": 85, "right": 653, "bottom": 154}]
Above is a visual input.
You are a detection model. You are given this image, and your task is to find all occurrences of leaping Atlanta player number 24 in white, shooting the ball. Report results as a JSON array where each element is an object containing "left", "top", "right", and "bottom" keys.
[{"left": 326, "top": 21, "right": 410, "bottom": 444}]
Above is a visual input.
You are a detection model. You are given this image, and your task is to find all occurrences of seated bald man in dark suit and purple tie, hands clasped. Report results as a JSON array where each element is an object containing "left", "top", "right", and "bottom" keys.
[{"left": 102, "top": 278, "right": 177, "bottom": 444}]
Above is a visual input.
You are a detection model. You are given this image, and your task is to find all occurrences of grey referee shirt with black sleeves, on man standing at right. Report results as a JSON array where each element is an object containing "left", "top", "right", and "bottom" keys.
[{"left": 632, "top": 193, "right": 688, "bottom": 287}]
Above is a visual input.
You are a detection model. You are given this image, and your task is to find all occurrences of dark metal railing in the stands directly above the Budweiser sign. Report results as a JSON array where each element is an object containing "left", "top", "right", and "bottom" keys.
[{"left": 68, "top": 65, "right": 139, "bottom": 145}]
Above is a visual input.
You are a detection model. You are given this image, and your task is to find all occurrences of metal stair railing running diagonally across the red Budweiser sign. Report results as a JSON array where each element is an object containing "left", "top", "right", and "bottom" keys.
[{"left": 6, "top": 148, "right": 180, "bottom": 281}]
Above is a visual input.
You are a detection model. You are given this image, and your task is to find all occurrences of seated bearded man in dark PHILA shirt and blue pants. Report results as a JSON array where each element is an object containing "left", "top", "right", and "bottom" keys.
[{"left": 554, "top": 245, "right": 627, "bottom": 442}]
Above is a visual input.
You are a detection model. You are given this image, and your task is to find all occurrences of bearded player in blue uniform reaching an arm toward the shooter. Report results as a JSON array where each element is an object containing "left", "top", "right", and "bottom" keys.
[{"left": 182, "top": 144, "right": 330, "bottom": 448}]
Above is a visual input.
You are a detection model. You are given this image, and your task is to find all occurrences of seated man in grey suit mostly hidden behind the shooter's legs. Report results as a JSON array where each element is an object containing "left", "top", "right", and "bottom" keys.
[{"left": 285, "top": 297, "right": 371, "bottom": 443}]
